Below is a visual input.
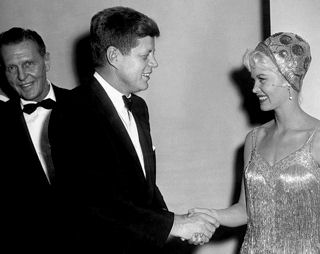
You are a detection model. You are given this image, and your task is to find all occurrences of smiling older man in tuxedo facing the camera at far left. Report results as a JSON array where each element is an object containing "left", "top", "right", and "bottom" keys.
[{"left": 0, "top": 27, "right": 67, "bottom": 252}]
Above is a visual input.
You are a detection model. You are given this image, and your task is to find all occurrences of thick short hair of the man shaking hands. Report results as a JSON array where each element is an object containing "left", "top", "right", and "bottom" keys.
[{"left": 90, "top": 6, "right": 160, "bottom": 66}]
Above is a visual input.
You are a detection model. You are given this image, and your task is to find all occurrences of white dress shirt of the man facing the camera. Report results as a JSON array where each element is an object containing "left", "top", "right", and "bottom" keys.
[{"left": 20, "top": 81, "right": 56, "bottom": 183}]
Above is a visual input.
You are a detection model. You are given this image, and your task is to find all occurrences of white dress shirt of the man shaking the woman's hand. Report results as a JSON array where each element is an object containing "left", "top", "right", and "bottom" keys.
[{"left": 93, "top": 72, "right": 146, "bottom": 176}]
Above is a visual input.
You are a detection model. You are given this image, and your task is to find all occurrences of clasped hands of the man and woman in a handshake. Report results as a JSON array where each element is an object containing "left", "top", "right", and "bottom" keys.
[{"left": 170, "top": 208, "right": 220, "bottom": 245}]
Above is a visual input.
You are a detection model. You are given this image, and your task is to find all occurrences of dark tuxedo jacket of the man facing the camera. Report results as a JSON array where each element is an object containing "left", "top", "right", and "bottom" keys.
[{"left": 0, "top": 86, "right": 68, "bottom": 253}]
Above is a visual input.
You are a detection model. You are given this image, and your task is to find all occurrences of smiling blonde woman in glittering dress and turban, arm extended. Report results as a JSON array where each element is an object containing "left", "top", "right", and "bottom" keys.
[{"left": 190, "top": 32, "right": 320, "bottom": 254}]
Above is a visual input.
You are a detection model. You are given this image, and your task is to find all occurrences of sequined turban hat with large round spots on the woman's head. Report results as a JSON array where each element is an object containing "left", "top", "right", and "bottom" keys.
[{"left": 255, "top": 32, "right": 311, "bottom": 92}]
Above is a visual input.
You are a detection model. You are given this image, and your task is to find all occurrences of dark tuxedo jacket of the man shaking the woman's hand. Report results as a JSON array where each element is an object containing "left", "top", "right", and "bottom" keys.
[{"left": 49, "top": 79, "right": 174, "bottom": 253}]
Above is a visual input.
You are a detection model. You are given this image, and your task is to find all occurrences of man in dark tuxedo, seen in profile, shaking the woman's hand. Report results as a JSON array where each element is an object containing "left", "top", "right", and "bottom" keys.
[{"left": 50, "top": 7, "right": 218, "bottom": 254}]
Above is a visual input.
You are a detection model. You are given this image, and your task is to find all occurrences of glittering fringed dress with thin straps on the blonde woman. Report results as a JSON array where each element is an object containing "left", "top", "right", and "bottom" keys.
[{"left": 241, "top": 129, "right": 320, "bottom": 254}]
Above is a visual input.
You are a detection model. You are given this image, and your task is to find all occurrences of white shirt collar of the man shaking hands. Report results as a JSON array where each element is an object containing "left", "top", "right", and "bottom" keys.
[{"left": 93, "top": 72, "right": 131, "bottom": 112}]
